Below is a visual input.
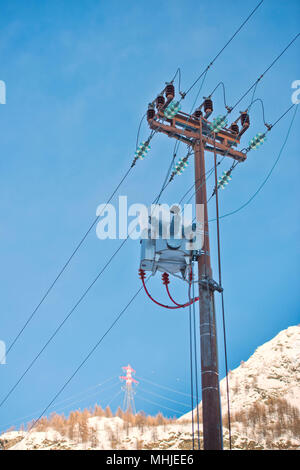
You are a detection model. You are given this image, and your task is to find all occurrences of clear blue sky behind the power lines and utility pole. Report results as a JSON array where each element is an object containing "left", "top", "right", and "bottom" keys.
[{"left": 0, "top": 0, "right": 300, "bottom": 423}]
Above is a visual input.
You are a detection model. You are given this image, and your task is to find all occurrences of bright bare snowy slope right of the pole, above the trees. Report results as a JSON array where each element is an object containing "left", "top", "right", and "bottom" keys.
[{"left": 179, "top": 325, "right": 300, "bottom": 420}]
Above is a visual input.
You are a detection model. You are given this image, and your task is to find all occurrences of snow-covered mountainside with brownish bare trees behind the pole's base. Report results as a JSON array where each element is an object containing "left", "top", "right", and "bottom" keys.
[{"left": 0, "top": 325, "right": 300, "bottom": 450}]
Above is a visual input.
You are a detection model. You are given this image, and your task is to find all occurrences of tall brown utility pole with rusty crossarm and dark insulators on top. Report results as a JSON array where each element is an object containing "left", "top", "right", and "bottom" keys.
[{"left": 147, "top": 90, "right": 249, "bottom": 450}]
